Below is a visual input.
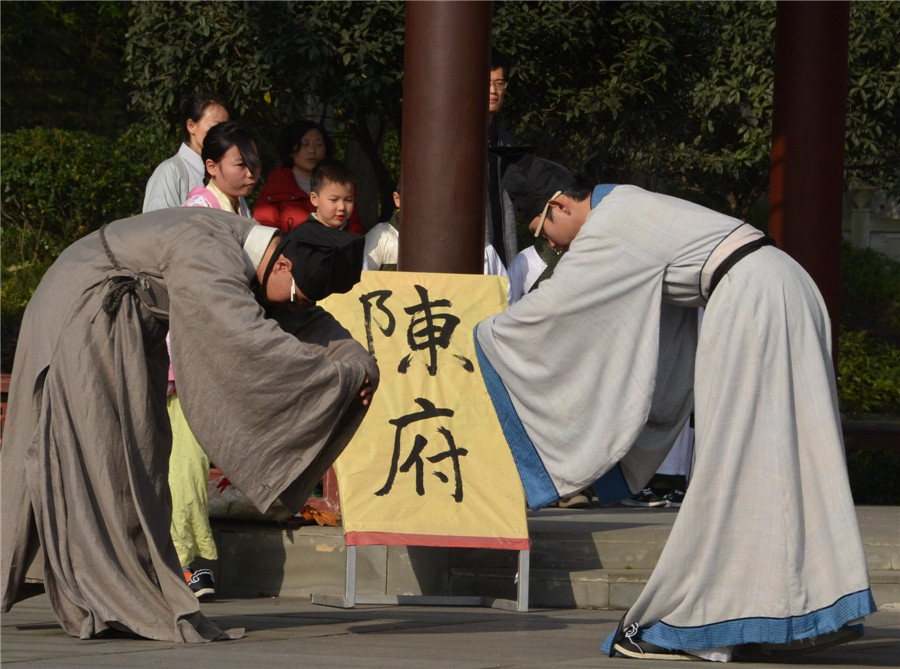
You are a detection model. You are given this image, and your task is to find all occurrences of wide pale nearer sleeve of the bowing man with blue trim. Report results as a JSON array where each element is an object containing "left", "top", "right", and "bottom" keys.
[{"left": 476, "top": 211, "right": 665, "bottom": 503}]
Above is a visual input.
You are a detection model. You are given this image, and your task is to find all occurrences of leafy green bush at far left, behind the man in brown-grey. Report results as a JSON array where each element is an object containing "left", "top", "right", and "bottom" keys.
[{"left": 0, "top": 126, "right": 172, "bottom": 371}]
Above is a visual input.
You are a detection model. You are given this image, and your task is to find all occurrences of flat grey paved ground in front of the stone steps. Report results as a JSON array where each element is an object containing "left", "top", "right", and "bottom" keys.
[{"left": 0, "top": 596, "right": 900, "bottom": 669}]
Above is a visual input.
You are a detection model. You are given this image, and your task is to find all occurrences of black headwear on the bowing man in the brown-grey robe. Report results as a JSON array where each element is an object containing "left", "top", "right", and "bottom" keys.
[{"left": 261, "top": 221, "right": 366, "bottom": 302}]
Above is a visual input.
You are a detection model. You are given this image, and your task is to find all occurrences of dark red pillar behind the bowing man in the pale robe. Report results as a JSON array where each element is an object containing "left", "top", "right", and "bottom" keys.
[{"left": 769, "top": 0, "right": 850, "bottom": 351}]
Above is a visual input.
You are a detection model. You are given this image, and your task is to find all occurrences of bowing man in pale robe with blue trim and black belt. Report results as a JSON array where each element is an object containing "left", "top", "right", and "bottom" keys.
[{"left": 475, "top": 156, "right": 875, "bottom": 660}]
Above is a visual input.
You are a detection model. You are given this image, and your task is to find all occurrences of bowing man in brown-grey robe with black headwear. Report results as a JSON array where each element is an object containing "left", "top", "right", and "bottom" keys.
[{"left": 0, "top": 208, "right": 378, "bottom": 642}]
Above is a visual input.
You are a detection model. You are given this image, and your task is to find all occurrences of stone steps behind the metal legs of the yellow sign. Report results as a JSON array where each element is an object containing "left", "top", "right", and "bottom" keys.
[{"left": 208, "top": 507, "right": 900, "bottom": 610}]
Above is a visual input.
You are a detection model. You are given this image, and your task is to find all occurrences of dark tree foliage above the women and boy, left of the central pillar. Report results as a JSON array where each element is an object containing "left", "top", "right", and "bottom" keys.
[{"left": 125, "top": 2, "right": 404, "bottom": 214}]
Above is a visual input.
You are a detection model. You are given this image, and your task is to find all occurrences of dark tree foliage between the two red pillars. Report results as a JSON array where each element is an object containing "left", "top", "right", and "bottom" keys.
[{"left": 494, "top": 2, "right": 775, "bottom": 214}]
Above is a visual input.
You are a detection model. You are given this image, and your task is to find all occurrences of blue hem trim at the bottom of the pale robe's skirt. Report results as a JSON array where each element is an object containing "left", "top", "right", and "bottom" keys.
[{"left": 602, "top": 588, "right": 876, "bottom": 653}]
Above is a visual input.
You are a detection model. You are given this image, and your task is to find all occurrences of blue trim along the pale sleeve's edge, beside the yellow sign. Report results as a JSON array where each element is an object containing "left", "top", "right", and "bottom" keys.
[{"left": 474, "top": 325, "right": 559, "bottom": 510}]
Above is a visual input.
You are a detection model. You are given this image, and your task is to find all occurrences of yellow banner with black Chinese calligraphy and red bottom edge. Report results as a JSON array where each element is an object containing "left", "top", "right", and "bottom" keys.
[{"left": 322, "top": 272, "right": 528, "bottom": 550}]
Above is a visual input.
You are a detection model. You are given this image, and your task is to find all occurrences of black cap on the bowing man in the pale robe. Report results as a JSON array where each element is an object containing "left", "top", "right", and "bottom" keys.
[{"left": 500, "top": 151, "right": 575, "bottom": 223}]
